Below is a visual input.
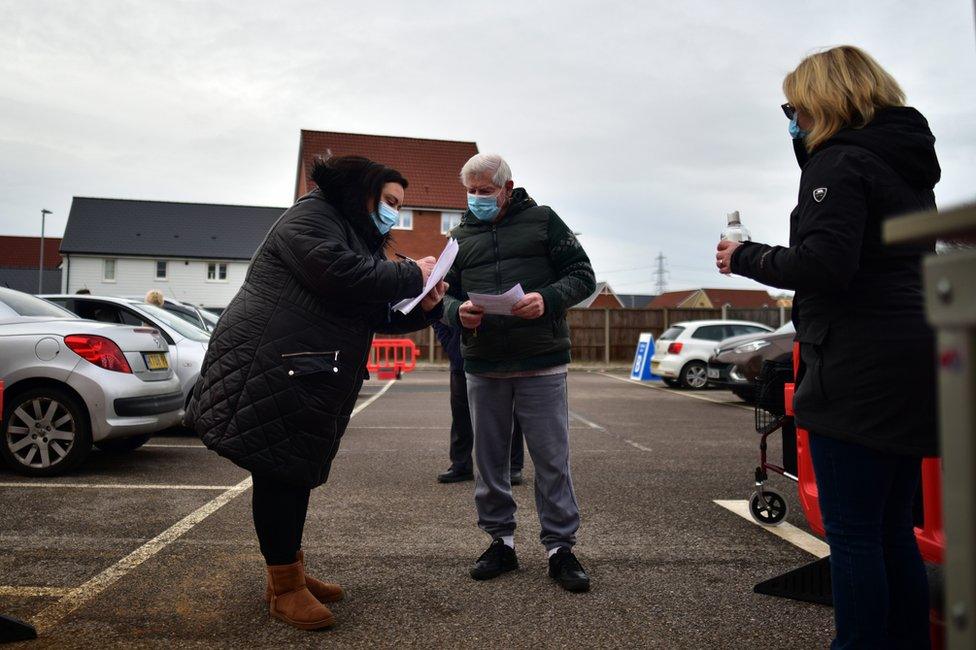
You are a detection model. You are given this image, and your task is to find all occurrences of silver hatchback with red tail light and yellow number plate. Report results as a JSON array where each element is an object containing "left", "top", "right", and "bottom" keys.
[{"left": 0, "top": 288, "right": 184, "bottom": 476}]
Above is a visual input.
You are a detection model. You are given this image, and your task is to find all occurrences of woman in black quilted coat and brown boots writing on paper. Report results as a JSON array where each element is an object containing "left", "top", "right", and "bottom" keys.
[{"left": 187, "top": 157, "right": 446, "bottom": 629}]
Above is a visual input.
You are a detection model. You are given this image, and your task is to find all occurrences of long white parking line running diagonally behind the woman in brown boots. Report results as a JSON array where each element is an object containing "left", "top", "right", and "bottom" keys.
[{"left": 33, "top": 380, "right": 395, "bottom": 633}]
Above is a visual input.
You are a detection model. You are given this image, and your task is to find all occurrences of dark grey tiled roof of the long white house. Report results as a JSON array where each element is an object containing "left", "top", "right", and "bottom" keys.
[{"left": 61, "top": 196, "right": 285, "bottom": 260}]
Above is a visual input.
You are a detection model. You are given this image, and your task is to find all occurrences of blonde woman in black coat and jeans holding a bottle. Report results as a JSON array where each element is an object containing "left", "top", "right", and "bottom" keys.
[{"left": 717, "top": 46, "right": 940, "bottom": 648}]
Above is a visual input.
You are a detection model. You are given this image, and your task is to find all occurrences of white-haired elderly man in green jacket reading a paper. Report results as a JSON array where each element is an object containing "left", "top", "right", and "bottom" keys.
[{"left": 444, "top": 154, "right": 596, "bottom": 591}]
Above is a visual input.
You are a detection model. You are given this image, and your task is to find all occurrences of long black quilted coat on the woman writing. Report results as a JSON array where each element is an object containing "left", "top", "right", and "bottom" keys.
[{"left": 186, "top": 190, "right": 427, "bottom": 487}]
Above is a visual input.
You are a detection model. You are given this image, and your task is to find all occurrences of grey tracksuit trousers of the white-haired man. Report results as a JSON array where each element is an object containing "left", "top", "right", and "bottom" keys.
[{"left": 467, "top": 373, "right": 580, "bottom": 550}]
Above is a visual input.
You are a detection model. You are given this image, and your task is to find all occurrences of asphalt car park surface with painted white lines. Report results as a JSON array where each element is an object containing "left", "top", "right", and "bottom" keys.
[{"left": 0, "top": 371, "right": 832, "bottom": 648}]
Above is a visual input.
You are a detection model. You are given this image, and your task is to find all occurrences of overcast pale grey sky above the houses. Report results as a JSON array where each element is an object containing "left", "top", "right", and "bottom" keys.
[{"left": 0, "top": 0, "right": 976, "bottom": 293}]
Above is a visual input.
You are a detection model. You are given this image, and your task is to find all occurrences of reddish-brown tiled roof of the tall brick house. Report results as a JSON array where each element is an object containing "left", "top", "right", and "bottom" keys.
[{"left": 295, "top": 129, "right": 478, "bottom": 210}]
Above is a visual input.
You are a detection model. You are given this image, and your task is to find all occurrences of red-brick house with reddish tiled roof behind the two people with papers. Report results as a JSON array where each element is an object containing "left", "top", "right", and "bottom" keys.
[{"left": 295, "top": 129, "right": 478, "bottom": 259}]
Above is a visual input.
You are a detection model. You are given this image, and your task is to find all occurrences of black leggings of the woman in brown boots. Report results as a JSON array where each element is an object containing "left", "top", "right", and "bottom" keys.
[{"left": 251, "top": 474, "right": 311, "bottom": 565}]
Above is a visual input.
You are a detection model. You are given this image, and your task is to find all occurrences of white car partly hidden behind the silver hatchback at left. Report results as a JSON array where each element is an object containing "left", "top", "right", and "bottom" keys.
[{"left": 41, "top": 294, "right": 210, "bottom": 407}]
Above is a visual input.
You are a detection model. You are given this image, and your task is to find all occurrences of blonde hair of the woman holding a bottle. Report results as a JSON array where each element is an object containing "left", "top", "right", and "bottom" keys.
[{"left": 783, "top": 45, "right": 905, "bottom": 151}]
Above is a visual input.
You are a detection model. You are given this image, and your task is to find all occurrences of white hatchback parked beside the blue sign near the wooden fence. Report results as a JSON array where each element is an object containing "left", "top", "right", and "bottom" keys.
[{"left": 651, "top": 320, "right": 773, "bottom": 390}]
